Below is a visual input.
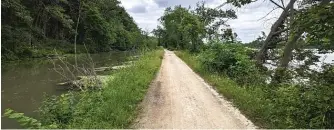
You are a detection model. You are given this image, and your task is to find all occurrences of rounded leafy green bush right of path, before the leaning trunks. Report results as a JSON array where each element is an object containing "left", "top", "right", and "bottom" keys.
[{"left": 199, "top": 43, "right": 265, "bottom": 84}]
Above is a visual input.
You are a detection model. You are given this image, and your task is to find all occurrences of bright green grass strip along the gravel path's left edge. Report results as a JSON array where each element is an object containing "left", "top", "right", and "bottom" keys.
[{"left": 70, "top": 50, "right": 163, "bottom": 128}]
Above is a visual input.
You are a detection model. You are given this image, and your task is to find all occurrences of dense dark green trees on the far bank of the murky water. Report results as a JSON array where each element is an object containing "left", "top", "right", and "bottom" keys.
[{"left": 1, "top": 0, "right": 155, "bottom": 60}]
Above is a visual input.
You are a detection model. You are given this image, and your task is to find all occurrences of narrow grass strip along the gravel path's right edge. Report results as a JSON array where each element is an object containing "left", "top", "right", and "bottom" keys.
[{"left": 176, "top": 51, "right": 275, "bottom": 128}]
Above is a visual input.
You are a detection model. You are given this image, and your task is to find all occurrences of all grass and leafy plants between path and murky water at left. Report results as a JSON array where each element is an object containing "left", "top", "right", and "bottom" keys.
[{"left": 5, "top": 49, "right": 163, "bottom": 129}]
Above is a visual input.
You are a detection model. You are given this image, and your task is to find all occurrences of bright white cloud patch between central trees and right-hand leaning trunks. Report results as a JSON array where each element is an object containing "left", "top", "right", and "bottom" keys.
[{"left": 223, "top": 1, "right": 282, "bottom": 42}]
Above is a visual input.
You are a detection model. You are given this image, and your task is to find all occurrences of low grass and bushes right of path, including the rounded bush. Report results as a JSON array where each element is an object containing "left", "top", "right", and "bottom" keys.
[{"left": 176, "top": 44, "right": 334, "bottom": 128}]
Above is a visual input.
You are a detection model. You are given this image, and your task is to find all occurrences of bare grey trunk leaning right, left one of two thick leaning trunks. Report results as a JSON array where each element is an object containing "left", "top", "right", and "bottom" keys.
[{"left": 256, "top": 0, "right": 296, "bottom": 64}]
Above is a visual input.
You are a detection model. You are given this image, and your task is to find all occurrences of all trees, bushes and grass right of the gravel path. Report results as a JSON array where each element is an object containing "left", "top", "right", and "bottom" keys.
[{"left": 160, "top": 0, "right": 334, "bottom": 128}]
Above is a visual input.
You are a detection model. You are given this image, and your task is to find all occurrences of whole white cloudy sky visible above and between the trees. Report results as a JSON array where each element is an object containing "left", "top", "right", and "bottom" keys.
[{"left": 120, "top": 0, "right": 286, "bottom": 43}]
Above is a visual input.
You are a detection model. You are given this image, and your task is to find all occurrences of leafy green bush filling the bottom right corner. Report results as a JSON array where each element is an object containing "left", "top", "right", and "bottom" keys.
[{"left": 271, "top": 69, "right": 334, "bottom": 129}]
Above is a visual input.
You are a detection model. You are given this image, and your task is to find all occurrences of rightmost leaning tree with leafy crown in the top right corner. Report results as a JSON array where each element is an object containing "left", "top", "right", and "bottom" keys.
[{"left": 275, "top": 1, "right": 334, "bottom": 82}]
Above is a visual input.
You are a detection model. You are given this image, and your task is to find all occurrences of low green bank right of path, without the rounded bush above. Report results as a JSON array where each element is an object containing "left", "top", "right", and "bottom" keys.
[{"left": 176, "top": 51, "right": 333, "bottom": 128}]
